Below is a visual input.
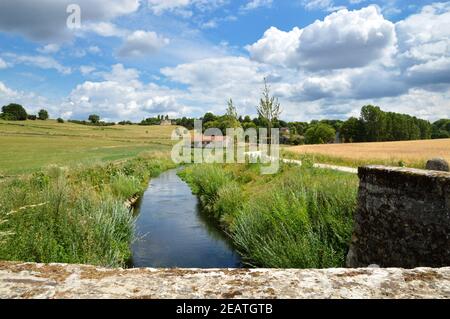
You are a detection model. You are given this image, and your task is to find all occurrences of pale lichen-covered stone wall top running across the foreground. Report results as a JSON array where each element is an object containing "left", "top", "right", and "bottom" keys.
[{"left": 0, "top": 262, "right": 450, "bottom": 299}]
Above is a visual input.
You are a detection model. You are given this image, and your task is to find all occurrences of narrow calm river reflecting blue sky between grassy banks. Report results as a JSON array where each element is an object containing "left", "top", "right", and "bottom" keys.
[{"left": 132, "top": 170, "right": 241, "bottom": 268}]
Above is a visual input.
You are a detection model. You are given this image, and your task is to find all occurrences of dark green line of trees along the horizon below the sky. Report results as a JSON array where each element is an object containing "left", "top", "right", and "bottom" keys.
[{"left": 0, "top": 98, "right": 450, "bottom": 145}]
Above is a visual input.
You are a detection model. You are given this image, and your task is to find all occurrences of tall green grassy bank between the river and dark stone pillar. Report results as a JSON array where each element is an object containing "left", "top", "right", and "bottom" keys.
[{"left": 181, "top": 165, "right": 358, "bottom": 268}]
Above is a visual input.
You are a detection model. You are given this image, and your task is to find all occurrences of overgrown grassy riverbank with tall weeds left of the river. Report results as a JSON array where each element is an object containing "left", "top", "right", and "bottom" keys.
[{"left": 0, "top": 153, "right": 173, "bottom": 267}]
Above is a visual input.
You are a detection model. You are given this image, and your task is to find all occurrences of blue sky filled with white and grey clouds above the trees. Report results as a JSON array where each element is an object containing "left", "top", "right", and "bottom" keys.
[{"left": 0, "top": 0, "right": 450, "bottom": 121}]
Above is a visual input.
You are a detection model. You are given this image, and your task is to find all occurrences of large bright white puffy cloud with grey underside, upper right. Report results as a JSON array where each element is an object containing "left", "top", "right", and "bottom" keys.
[{"left": 247, "top": 6, "right": 396, "bottom": 70}]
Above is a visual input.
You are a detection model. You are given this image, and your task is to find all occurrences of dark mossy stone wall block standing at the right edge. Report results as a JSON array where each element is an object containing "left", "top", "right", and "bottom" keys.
[{"left": 347, "top": 166, "right": 450, "bottom": 268}]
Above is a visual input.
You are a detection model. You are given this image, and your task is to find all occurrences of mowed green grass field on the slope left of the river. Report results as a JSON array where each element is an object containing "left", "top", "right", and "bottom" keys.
[{"left": 0, "top": 120, "right": 174, "bottom": 176}]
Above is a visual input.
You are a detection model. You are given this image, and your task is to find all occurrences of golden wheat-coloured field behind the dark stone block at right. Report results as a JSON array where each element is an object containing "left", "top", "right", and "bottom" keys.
[{"left": 285, "top": 139, "right": 450, "bottom": 168}]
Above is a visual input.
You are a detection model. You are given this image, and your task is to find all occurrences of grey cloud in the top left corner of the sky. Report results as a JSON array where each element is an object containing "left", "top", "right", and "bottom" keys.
[{"left": 0, "top": 0, "right": 139, "bottom": 42}]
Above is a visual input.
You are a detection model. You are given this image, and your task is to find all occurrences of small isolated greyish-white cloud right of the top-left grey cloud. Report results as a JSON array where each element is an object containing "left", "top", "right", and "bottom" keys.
[{"left": 118, "top": 30, "right": 169, "bottom": 57}]
